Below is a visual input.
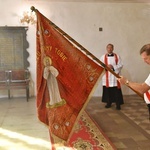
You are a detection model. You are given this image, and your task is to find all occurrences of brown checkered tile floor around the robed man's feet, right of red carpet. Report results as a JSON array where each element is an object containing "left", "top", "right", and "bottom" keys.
[{"left": 86, "top": 95, "right": 150, "bottom": 150}]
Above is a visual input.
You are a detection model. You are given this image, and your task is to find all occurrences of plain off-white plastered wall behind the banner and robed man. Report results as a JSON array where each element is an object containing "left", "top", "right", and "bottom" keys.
[{"left": 0, "top": 0, "right": 150, "bottom": 96}]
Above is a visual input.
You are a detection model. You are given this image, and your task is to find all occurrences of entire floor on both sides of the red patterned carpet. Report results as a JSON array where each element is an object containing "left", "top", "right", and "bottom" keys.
[{"left": 0, "top": 96, "right": 150, "bottom": 150}]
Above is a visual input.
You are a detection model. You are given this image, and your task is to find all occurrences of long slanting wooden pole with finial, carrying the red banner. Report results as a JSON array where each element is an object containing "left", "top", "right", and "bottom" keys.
[{"left": 31, "top": 6, "right": 144, "bottom": 99}]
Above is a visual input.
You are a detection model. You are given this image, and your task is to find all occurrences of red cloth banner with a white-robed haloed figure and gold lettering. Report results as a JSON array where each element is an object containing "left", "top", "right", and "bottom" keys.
[{"left": 36, "top": 11, "right": 103, "bottom": 141}]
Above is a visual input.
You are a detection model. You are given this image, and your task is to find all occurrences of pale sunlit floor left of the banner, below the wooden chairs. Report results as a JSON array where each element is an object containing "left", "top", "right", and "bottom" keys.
[{"left": 0, "top": 98, "right": 50, "bottom": 150}]
